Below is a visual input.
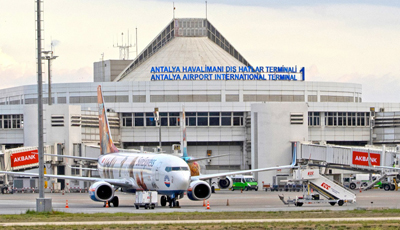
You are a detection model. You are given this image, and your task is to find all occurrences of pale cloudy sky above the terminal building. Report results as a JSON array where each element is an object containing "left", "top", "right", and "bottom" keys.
[{"left": 0, "top": 0, "right": 400, "bottom": 103}]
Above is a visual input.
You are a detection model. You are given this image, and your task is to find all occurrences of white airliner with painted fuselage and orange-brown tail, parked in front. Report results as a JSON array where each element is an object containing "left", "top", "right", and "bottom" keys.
[{"left": 0, "top": 85, "right": 297, "bottom": 207}]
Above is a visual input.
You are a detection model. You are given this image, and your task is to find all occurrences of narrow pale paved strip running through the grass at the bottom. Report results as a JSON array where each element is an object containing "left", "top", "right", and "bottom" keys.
[{"left": 0, "top": 217, "right": 400, "bottom": 227}]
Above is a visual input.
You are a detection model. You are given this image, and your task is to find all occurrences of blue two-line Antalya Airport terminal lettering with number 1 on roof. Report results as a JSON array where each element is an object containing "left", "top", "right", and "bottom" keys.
[{"left": 150, "top": 66, "right": 305, "bottom": 81}]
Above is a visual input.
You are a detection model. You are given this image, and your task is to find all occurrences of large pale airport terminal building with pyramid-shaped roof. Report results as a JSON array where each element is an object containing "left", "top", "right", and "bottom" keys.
[{"left": 0, "top": 18, "right": 400, "bottom": 187}]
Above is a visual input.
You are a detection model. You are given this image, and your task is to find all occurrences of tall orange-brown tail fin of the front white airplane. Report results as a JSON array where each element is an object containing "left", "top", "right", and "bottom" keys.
[{"left": 97, "top": 85, "right": 118, "bottom": 155}]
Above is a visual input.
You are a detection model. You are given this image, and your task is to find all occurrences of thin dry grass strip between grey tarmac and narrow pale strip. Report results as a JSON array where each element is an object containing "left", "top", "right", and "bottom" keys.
[{"left": 0, "top": 209, "right": 400, "bottom": 223}]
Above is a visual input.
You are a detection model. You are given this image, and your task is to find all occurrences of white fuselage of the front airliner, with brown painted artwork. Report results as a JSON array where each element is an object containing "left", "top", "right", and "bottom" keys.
[{"left": 98, "top": 153, "right": 190, "bottom": 195}]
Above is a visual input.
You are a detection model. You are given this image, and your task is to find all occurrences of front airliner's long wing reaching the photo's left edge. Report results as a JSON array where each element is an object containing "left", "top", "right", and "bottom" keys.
[{"left": 0, "top": 171, "right": 132, "bottom": 187}]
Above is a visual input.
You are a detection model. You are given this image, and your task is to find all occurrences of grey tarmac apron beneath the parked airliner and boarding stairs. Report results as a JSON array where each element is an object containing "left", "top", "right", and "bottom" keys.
[{"left": 0, "top": 189, "right": 400, "bottom": 214}]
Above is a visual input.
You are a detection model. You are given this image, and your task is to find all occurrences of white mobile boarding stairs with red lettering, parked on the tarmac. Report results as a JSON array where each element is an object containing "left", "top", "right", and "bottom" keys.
[{"left": 278, "top": 168, "right": 356, "bottom": 207}]
